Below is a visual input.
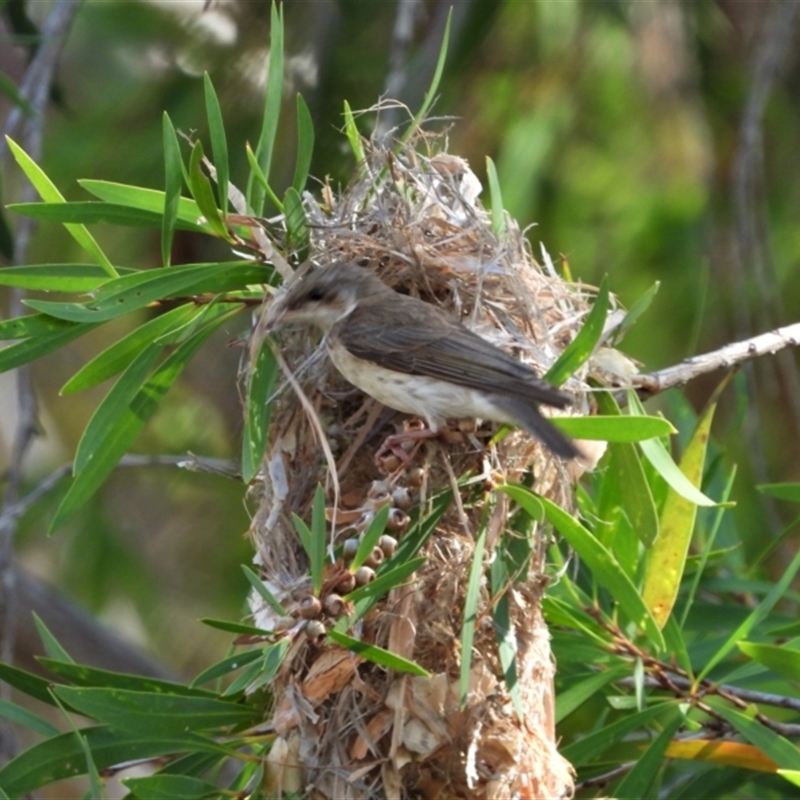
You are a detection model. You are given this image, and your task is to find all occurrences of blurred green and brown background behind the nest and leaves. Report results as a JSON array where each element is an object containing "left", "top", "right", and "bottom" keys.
[{"left": 0, "top": 0, "right": 800, "bottom": 677}]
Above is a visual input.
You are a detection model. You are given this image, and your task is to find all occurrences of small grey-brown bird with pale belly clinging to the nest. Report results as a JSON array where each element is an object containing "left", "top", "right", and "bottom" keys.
[{"left": 264, "top": 261, "right": 581, "bottom": 459}]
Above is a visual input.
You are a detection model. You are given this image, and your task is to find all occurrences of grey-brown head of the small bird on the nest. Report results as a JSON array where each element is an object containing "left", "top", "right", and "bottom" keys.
[{"left": 265, "top": 264, "right": 392, "bottom": 332}]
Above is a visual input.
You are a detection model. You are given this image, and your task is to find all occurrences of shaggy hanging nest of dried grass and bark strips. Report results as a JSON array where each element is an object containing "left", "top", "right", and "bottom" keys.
[{"left": 245, "top": 128, "right": 612, "bottom": 800}]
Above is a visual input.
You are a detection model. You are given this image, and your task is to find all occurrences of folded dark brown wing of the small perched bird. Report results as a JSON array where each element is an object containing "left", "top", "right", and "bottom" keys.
[{"left": 332, "top": 294, "right": 570, "bottom": 408}]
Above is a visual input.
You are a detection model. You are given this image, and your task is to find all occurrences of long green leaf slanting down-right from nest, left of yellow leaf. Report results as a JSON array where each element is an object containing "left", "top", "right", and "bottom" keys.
[{"left": 540, "top": 497, "right": 664, "bottom": 650}]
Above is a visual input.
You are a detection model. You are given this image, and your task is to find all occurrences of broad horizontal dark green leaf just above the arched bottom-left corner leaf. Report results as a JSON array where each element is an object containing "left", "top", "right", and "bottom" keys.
[{"left": 53, "top": 686, "right": 260, "bottom": 738}]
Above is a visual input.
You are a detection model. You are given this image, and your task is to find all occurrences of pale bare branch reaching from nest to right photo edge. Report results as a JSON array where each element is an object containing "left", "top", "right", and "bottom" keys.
[{"left": 632, "top": 322, "right": 800, "bottom": 395}]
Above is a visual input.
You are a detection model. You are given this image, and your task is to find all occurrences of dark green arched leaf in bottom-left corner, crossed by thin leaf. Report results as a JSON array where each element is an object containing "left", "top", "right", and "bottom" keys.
[{"left": 0, "top": 720, "right": 225, "bottom": 797}]
